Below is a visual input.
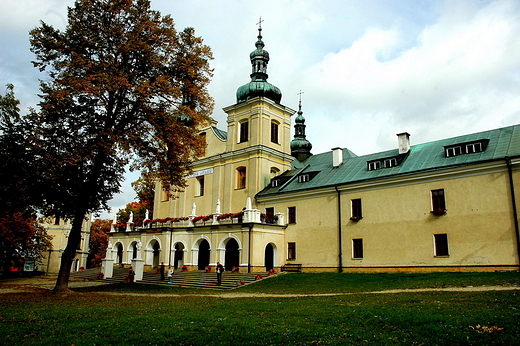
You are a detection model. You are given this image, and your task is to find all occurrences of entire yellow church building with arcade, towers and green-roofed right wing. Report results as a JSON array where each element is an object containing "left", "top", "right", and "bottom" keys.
[{"left": 105, "top": 29, "right": 520, "bottom": 272}]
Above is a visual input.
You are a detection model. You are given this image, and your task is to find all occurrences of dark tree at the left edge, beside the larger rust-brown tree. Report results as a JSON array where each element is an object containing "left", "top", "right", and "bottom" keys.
[{"left": 0, "top": 84, "right": 51, "bottom": 272}]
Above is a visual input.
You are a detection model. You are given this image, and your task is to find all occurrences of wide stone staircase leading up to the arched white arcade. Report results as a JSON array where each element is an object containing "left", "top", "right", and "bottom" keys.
[{"left": 71, "top": 268, "right": 276, "bottom": 290}]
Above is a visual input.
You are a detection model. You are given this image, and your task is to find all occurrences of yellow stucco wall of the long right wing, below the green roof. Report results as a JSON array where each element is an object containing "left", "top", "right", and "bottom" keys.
[{"left": 261, "top": 163, "right": 520, "bottom": 269}]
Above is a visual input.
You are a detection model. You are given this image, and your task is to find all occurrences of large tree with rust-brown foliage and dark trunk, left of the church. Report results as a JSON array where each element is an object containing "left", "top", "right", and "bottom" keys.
[{"left": 30, "top": 0, "right": 213, "bottom": 292}]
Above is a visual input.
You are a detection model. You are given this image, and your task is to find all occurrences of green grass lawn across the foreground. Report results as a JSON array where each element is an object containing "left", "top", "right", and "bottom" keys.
[{"left": 0, "top": 273, "right": 520, "bottom": 345}]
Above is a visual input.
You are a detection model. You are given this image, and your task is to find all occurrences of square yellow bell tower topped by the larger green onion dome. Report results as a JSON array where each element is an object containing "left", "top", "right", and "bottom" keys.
[{"left": 224, "top": 20, "right": 296, "bottom": 196}]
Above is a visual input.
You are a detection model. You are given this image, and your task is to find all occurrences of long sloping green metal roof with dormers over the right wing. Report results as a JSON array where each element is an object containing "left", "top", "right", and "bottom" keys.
[{"left": 257, "top": 125, "right": 520, "bottom": 197}]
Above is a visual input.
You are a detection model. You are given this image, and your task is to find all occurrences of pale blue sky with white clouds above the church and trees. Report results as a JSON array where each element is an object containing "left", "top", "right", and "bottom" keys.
[{"left": 0, "top": 0, "right": 520, "bottom": 218}]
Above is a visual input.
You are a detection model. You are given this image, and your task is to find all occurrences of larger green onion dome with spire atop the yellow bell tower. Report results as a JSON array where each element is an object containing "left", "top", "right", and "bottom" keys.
[{"left": 237, "top": 27, "right": 282, "bottom": 103}]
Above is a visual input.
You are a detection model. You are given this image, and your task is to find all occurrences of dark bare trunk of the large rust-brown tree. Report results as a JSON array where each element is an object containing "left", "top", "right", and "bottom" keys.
[{"left": 52, "top": 214, "right": 85, "bottom": 293}]
